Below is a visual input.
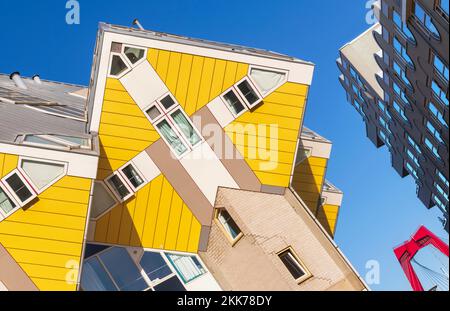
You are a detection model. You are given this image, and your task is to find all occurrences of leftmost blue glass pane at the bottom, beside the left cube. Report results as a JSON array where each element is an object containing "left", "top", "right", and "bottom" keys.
[{"left": 81, "top": 257, "right": 117, "bottom": 291}]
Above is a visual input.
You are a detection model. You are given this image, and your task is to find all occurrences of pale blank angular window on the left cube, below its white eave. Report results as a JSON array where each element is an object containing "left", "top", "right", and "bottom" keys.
[{"left": 20, "top": 159, "right": 66, "bottom": 192}]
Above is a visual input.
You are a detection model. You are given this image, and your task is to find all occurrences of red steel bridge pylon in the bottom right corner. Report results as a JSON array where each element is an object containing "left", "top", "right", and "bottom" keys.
[{"left": 394, "top": 226, "right": 449, "bottom": 291}]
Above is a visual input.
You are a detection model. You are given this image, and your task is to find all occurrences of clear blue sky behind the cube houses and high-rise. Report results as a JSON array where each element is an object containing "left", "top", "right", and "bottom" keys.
[{"left": 0, "top": 0, "right": 445, "bottom": 290}]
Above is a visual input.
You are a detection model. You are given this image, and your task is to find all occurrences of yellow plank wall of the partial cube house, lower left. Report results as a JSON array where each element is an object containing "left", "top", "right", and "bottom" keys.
[{"left": 0, "top": 176, "right": 91, "bottom": 290}]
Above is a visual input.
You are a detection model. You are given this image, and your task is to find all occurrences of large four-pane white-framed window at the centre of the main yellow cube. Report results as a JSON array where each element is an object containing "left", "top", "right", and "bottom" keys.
[{"left": 145, "top": 94, "right": 203, "bottom": 157}]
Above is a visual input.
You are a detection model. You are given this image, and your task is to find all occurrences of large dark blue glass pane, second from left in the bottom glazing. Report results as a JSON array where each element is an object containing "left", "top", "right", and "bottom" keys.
[{"left": 99, "top": 247, "right": 149, "bottom": 291}]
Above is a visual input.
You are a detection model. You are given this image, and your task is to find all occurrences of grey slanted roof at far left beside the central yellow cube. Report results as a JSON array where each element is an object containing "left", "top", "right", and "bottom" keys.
[{"left": 0, "top": 74, "right": 91, "bottom": 143}]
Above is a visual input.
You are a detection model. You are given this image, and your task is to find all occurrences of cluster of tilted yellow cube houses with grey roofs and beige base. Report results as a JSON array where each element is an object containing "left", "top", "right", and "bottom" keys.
[{"left": 0, "top": 24, "right": 367, "bottom": 291}]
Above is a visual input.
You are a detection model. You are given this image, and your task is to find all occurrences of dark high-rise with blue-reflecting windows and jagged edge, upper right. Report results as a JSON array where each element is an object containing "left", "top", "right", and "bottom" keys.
[{"left": 337, "top": 0, "right": 449, "bottom": 231}]
